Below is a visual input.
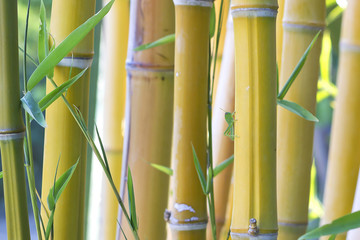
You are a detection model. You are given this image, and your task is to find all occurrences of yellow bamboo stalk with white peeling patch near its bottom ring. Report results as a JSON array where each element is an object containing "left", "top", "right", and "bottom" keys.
[{"left": 169, "top": 0, "right": 213, "bottom": 240}]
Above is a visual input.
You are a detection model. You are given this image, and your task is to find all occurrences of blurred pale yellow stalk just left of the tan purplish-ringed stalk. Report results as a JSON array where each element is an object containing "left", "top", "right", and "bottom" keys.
[{"left": 98, "top": 0, "right": 130, "bottom": 239}]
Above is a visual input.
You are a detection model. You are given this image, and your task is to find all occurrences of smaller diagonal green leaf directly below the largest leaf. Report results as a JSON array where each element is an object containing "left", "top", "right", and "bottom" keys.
[{"left": 39, "top": 68, "right": 87, "bottom": 111}]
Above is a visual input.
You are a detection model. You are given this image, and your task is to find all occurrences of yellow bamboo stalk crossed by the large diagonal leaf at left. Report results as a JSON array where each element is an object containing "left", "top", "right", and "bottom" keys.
[{"left": 41, "top": 0, "right": 95, "bottom": 239}]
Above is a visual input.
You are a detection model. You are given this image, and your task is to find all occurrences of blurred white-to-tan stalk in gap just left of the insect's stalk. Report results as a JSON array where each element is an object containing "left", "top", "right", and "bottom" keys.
[{"left": 207, "top": 16, "right": 235, "bottom": 239}]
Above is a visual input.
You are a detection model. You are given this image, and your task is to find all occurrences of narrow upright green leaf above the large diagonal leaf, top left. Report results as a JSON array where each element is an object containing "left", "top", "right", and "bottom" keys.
[{"left": 38, "top": 0, "right": 49, "bottom": 62}]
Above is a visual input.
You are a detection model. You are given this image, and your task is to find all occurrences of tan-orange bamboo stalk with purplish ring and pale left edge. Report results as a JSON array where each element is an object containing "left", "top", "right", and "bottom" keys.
[{"left": 118, "top": 0, "right": 175, "bottom": 239}]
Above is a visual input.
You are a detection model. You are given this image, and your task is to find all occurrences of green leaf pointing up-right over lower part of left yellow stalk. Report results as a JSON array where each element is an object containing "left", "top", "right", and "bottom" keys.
[{"left": 47, "top": 158, "right": 80, "bottom": 211}]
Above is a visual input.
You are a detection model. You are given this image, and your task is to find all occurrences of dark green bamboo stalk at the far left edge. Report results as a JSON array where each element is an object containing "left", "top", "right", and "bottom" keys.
[{"left": 0, "top": 0, "right": 30, "bottom": 239}]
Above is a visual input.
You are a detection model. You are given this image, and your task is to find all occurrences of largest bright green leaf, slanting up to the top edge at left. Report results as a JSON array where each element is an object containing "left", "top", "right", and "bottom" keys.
[{"left": 27, "top": 0, "right": 115, "bottom": 90}]
